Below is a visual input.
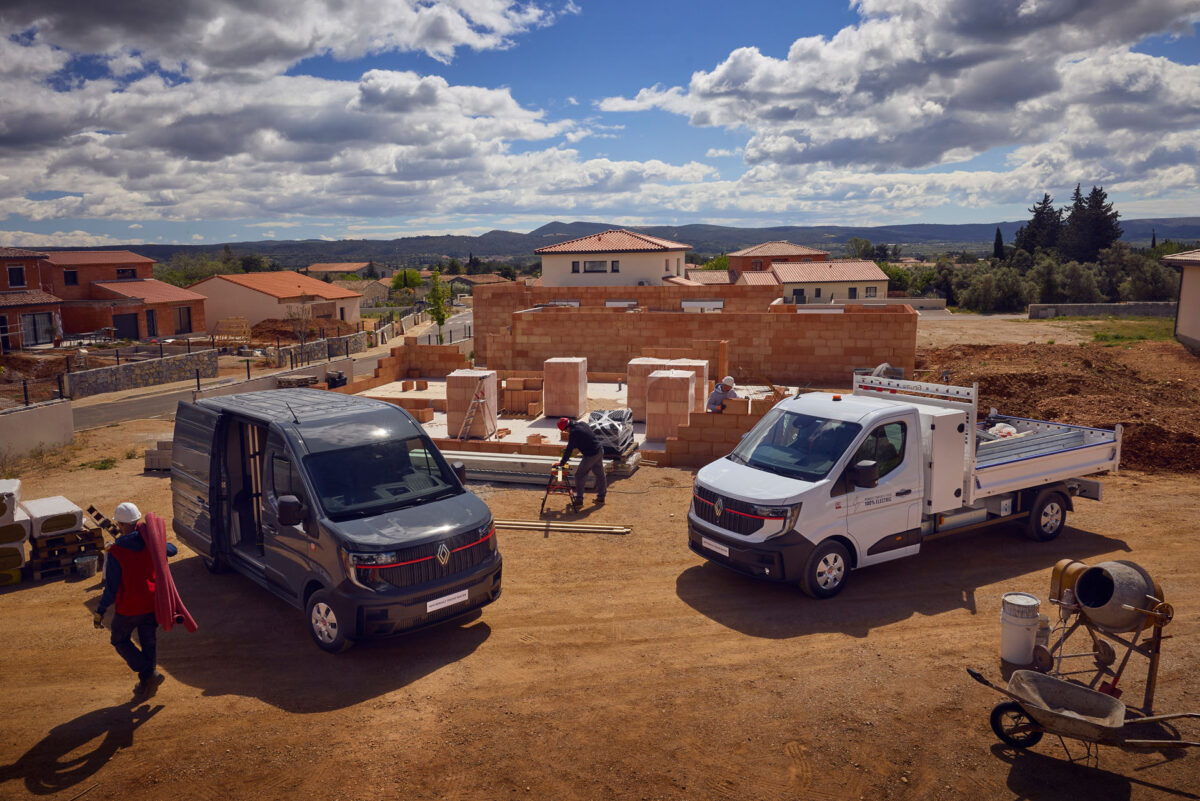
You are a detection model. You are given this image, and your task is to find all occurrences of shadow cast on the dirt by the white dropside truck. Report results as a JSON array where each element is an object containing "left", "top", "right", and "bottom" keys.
[{"left": 676, "top": 525, "right": 1129, "bottom": 639}]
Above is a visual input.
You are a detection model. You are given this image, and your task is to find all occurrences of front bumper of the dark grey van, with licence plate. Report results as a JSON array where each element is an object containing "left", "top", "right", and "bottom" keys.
[{"left": 342, "top": 553, "right": 503, "bottom": 639}]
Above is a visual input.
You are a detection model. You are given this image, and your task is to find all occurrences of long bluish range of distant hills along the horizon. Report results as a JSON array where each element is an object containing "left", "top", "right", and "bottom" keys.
[{"left": 41, "top": 217, "right": 1200, "bottom": 269}]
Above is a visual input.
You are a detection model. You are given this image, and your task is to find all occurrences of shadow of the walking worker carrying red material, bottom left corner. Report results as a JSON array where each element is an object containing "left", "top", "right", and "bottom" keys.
[{"left": 0, "top": 699, "right": 162, "bottom": 795}]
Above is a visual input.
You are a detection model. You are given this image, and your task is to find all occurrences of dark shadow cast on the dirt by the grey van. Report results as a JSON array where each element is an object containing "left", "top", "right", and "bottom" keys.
[{"left": 151, "top": 556, "right": 491, "bottom": 713}]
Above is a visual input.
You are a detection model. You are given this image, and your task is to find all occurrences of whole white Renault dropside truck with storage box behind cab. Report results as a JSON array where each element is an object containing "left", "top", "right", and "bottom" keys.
[{"left": 688, "top": 375, "right": 1121, "bottom": 598}]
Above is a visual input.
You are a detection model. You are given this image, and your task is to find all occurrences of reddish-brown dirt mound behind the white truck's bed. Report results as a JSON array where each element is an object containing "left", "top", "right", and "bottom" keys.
[{"left": 917, "top": 342, "right": 1200, "bottom": 472}]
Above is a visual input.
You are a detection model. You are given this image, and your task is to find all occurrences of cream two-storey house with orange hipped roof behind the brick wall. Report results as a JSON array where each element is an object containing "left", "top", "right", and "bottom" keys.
[{"left": 534, "top": 229, "right": 691, "bottom": 287}]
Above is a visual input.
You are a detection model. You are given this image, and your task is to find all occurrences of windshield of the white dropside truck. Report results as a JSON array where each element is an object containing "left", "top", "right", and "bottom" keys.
[{"left": 727, "top": 409, "right": 863, "bottom": 481}]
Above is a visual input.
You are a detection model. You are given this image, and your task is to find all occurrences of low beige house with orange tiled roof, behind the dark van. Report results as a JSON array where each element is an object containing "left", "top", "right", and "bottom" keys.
[{"left": 188, "top": 270, "right": 362, "bottom": 331}]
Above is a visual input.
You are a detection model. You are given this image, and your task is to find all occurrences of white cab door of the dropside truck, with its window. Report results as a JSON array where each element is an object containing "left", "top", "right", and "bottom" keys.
[{"left": 845, "top": 418, "right": 922, "bottom": 567}]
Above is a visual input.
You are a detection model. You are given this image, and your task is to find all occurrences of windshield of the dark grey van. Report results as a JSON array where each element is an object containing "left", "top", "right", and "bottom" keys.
[{"left": 305, "top": 436, "right": 461, "bottom": 518}]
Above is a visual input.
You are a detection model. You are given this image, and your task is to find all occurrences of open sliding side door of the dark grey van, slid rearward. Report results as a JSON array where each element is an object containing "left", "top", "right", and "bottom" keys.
[{"left": 170, "top": 403, "right": 224, "bottom": 558}]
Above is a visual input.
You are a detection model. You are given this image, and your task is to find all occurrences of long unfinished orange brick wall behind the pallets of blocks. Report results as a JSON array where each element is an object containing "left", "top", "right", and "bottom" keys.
[{"left": 488, "top": 303, "right": 917, "bottom": 386}]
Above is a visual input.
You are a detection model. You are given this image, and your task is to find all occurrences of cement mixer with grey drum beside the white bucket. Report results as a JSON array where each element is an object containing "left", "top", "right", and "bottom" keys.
[{"left": 1033, "top": 559, "right": 1175, "bottom": 715}]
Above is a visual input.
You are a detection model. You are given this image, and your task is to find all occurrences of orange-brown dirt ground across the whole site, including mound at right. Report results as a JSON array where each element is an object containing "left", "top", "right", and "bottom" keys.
[{"left": 0, "top": 320, "right": 1200, "bottom": 801}]
